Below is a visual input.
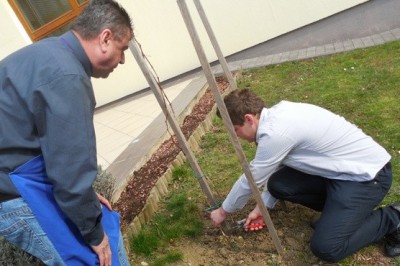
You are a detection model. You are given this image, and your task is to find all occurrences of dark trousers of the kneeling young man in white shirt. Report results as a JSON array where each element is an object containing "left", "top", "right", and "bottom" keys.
[{"left": 268, "top": 163, "right": 400, "bottom": 262}]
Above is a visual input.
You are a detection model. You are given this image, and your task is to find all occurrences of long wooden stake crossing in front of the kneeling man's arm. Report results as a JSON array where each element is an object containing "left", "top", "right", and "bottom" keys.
[{"left": 177, "top": 0, "right": 283, "bottom": 254}]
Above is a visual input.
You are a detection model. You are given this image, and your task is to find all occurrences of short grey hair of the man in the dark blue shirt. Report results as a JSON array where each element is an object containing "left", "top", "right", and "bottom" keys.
[{"left": 71, "top": 0, "right": 133, "bottom": 40}]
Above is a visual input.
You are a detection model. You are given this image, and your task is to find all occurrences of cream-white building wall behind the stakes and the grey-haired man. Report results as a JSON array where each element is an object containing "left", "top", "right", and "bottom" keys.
[{"left": 0, "top": 0, "right": 367, "bottom": 106}]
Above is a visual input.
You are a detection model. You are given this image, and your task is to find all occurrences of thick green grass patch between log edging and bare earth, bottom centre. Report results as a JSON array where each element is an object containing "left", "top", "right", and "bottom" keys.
[{"left": 129, "top": 167, "right": 204, "bottom": 265}]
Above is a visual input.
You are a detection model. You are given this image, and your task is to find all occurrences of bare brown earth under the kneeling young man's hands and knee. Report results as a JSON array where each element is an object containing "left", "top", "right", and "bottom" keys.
[{"left": 171, "top": 203, "right": 393, "bottom": 266}]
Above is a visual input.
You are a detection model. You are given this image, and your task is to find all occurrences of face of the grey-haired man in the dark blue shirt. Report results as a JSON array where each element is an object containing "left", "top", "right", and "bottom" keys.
[{"left": 92, "top": 28, "right": 131, "bottom": 78}]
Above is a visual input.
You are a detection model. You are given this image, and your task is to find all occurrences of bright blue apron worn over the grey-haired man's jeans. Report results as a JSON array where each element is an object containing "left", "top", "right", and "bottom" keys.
[{"left": 9, "top": 155, "right": 120, "bottom": 266}]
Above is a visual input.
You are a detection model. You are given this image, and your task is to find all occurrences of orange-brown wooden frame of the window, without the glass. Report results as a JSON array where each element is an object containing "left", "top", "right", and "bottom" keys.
[{"left": 8, "top": 0, "right": 89, "bottom": 42}]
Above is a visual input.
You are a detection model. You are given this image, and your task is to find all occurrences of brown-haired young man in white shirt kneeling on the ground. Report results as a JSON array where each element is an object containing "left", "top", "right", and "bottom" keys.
[{"left": 211, "top": 89, "right": 400, "bottom": 262}]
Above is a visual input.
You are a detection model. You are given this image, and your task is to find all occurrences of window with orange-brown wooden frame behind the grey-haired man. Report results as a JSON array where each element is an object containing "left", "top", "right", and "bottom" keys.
[{"left": 8, "top": 0, "right": 89, "bottom": 42}]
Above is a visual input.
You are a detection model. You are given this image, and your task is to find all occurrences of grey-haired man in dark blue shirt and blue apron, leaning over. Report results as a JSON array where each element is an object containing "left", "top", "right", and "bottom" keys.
[{"left": 0, "top": 0, "right": 133, "bottom": 265}]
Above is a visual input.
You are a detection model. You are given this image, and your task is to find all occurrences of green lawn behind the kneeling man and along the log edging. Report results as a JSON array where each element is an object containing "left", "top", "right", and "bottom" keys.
[{"left": 131, "top": 41, "right": 400, "bottom": 265}]
